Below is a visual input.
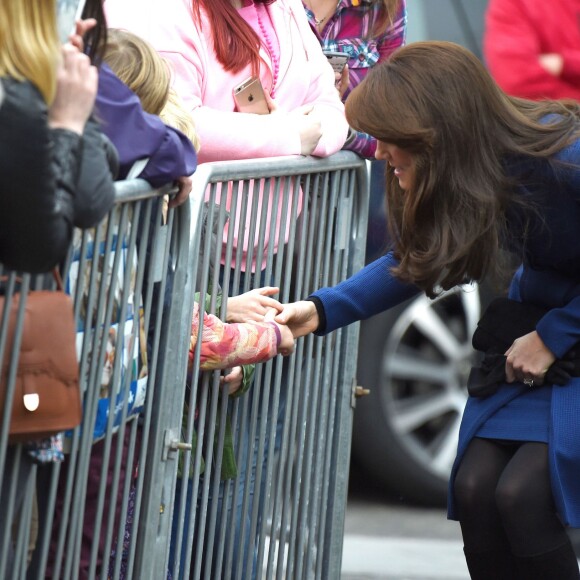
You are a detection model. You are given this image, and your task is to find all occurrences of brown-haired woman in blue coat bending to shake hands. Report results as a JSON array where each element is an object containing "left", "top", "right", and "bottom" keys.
[{"left": 277, "top": 42, "right": 580, "bottom": 580}]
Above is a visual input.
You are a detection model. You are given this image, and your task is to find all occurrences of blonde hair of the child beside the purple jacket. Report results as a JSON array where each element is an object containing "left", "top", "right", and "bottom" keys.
[{"left": 103, "top": 28, "right": 199, "bottom": 150}]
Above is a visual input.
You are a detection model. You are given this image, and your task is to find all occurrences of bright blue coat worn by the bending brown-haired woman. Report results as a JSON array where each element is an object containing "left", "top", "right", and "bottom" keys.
[{"left": 313, "top": 135, "right": 580, "bottom": 527}]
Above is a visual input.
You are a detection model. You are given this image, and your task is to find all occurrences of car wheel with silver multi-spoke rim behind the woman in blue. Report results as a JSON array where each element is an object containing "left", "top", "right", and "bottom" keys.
[{"left": 353, "top": 285, "right": 481, "bottom": 505}]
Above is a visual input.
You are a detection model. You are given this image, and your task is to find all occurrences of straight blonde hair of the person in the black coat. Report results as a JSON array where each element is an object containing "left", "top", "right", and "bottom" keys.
[{"left": 0, "top": 0, "right": 61, "bottom": 105}]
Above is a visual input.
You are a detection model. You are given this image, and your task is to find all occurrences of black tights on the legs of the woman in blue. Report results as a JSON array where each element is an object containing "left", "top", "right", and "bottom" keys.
[{"left": 454, "top": 438, "right": 569, "bottom": 557}]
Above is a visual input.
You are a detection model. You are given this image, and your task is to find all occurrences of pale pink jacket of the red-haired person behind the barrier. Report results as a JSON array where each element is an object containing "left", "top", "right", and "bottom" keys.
[{"left": 105, "top": 0, "right": 348, "bottom": 163}]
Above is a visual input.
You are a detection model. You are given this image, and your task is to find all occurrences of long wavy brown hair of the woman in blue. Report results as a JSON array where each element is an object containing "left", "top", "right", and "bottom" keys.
[{"left": 346, "top": 42, "right": 580, "bottom": 296}]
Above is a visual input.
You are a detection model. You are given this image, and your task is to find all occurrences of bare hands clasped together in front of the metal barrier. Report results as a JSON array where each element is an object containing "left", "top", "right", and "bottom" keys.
[{"left": 226, "top": 286, "right": 319, "bottom": 356}]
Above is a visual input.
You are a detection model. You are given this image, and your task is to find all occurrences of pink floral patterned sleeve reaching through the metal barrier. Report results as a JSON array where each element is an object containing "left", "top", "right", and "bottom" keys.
[{"left": 189, "top": 302, "right": 281, "bottom": 371}]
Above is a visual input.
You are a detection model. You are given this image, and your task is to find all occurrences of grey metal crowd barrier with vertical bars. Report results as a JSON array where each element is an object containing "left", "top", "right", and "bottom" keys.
[{"left": 0, "top": 152, "right": 368, "bottom": 580}]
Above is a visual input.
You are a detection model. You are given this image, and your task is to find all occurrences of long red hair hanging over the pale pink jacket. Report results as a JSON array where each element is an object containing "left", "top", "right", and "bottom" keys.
[{"left": 192, "top": 0, "right": 276, "bottom": 75}]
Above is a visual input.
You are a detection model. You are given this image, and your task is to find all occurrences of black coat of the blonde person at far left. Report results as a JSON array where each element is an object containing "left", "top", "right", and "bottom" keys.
[{"left": 0, "top": 77, "right": 116, "bottom": 273}]
